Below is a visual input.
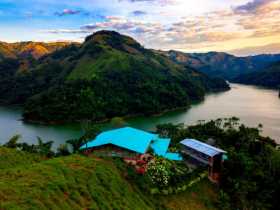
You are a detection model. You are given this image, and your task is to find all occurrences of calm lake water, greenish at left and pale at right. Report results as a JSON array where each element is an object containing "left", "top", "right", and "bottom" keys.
[{"left": 0, "top": 84, "right": 280, "bottom": 147}]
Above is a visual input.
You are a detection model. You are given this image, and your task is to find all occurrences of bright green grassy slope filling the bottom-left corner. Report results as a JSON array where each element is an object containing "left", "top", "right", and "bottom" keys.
[{"left": 0, "top": 149, "right": 155, "bottom": 210}]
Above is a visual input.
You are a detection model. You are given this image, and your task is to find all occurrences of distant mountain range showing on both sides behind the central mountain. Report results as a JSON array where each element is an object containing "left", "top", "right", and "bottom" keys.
[{"left": 0, "top": 41, "right": 280, "bottom": 81}]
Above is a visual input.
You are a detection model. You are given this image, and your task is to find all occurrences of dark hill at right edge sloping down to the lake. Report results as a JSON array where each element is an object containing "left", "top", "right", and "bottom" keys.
[{"left": 234, "top": 62, "right": 280, "bottom": 88}]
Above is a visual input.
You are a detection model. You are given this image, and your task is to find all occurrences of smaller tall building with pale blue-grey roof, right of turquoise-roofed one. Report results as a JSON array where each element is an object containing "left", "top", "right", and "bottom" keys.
[{"left": 180, "top": 139, "right": 226, "bottom": 183}]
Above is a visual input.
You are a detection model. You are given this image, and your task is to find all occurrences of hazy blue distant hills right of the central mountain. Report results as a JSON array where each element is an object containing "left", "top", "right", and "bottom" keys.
[{"left": 162, "top": 51, "right": 280, "bottom": 80}]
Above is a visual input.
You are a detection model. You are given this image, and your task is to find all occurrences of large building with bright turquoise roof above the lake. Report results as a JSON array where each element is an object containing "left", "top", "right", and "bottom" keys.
[{"left": 80, "top": 127, "right": 182, "bottom": 161}]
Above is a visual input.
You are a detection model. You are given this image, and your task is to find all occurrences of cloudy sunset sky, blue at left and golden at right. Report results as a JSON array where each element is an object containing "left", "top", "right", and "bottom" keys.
[{"left": 0, "top": 0, "right": 280, "bottom": 56}]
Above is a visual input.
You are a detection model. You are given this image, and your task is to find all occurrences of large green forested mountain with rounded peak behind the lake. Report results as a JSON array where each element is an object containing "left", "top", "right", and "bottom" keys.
[{"left": 0, "top": 31, "right": 229, "bottom": 122}]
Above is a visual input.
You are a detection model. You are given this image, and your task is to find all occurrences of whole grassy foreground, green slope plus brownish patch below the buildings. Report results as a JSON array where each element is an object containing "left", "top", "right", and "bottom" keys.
[{"left": 0, "top": 147, "right": 219, "bottom": 210}]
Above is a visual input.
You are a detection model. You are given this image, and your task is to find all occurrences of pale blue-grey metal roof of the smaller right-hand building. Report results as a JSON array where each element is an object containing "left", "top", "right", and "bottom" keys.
[{"left": 180, "top": 139, "right": 226, "bottom": 157}]
